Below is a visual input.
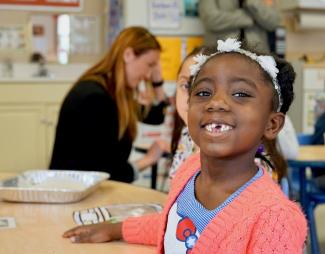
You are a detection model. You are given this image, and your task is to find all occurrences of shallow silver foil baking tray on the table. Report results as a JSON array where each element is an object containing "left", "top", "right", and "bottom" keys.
[{"left": 0, "top": 170, "right": 109, "bottom": 203}]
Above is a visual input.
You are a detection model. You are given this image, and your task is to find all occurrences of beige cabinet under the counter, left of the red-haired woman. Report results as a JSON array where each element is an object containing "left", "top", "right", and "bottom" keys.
[{"left": 0, "top": 84, "right": 71, "bottom": 171}]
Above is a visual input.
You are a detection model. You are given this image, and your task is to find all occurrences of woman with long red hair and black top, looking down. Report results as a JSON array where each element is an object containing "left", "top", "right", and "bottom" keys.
[{"left": 50, "top": 27, "right": 167, "bottom": 182}]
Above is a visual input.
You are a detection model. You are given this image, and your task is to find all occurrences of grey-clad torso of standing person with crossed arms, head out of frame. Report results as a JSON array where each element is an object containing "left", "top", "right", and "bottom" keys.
[{"left": 199, "top": 0, "right": 281, "bottom": 51}]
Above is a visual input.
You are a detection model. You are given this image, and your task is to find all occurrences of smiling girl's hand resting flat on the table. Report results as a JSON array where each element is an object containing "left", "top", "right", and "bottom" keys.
[{"left": 62, "top": 222, "right": 122, "bottom": 243}]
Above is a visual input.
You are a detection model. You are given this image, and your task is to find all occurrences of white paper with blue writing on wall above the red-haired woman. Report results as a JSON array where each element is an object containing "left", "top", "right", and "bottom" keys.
[{"left": 149, "top": 0, "right": 181, "bottom": 29}]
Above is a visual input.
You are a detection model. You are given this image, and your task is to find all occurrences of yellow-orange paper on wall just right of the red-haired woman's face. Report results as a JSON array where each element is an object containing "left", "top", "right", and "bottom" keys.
[{"left": 157, "top": 37, "right": 182, "bottom": 80}]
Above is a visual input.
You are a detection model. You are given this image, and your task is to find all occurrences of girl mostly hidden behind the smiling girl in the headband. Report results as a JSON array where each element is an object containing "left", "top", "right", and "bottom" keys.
[{"left": 169, "top": 47, "right": 290, "bottom": 188}]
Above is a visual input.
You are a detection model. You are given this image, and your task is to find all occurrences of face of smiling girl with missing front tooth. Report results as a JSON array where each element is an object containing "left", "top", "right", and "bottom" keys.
[{"left": 188, "top": 53, "right": 283, "bottom": 158}]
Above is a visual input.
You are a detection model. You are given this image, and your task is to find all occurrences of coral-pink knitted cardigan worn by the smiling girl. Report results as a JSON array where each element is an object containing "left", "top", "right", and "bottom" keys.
[{"left": 122, "top": 154, "right": 307, "bottom": 254}]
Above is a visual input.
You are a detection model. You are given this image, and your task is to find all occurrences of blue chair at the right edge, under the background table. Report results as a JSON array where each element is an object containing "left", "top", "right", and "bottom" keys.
[{"left": 288, "top": 160, "right": 325, "bottom": 254}]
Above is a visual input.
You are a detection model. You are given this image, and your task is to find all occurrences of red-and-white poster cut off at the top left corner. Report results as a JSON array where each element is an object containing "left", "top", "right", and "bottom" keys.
[{"left": 0, "top": 0, "right": 83, "bottom": 11}]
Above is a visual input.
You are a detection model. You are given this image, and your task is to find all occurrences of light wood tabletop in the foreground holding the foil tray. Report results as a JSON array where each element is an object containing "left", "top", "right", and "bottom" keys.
[{"left": 0, "top": 173, "right": 166, "bottom": 254}]
